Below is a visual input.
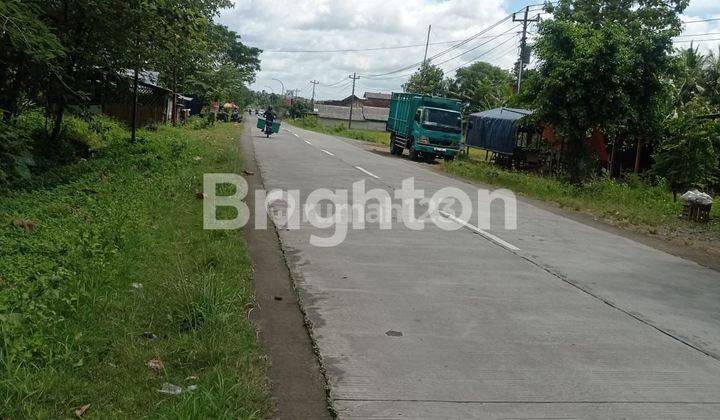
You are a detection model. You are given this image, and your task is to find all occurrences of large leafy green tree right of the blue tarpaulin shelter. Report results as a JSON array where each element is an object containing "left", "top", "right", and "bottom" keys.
[{"left": 534, "top": 0, "right": 688, "bottom": 181}]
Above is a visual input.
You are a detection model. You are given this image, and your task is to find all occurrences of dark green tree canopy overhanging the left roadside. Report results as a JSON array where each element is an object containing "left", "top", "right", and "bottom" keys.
[{"left": 0, "top": 0, "right": 260, "bottom": 146}]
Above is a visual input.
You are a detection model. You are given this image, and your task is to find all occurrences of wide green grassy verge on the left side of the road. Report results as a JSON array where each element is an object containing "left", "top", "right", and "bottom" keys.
[{"left": 0, "top": 124, "right": 270, "bottom": 418}]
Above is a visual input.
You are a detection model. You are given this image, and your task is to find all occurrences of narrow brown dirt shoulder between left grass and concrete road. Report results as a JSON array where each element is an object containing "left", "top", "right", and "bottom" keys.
[{"left": 241, "top": 121, "right": 332, "bottom": 419}]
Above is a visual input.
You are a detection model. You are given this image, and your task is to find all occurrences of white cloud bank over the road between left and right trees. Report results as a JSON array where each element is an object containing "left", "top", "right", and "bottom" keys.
[{"left": 219, "top": 0, "right": 519, "bottom": 98}]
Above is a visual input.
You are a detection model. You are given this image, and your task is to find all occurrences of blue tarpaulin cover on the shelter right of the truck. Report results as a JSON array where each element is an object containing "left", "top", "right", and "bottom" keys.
[{"left": 465, "top": 108, "right": 532, "bottom": 155}]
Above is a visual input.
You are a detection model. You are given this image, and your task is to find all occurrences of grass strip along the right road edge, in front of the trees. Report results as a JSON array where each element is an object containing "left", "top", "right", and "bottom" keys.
[{"left": 442, "top": 153, "right": 720, "bottom": 234}]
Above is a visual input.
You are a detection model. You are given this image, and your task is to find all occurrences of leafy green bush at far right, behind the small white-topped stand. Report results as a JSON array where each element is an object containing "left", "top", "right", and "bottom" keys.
[{"left": 653, "top": 99, "right": 718, "bottom": 197}]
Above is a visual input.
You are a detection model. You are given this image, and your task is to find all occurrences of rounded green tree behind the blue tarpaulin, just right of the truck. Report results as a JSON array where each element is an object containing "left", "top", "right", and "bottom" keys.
[{"left": 447, "top": 61, "right": 512, "bottom": 113}]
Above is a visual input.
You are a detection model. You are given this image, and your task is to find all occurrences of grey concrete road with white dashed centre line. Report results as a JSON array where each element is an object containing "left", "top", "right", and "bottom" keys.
[{"left": 246, "top": 120, "right": 720, "bottom": 419}]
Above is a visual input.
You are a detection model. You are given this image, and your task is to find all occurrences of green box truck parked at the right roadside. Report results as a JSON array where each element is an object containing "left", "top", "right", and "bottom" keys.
[{"left": 385, "top": 93, "right": 461, "bottom": 160}]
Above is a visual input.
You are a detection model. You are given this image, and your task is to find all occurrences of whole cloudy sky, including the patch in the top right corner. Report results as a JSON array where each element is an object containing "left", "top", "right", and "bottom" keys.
[{"left": 218, "top": 0, "right": 720, "bottom": 99}]
